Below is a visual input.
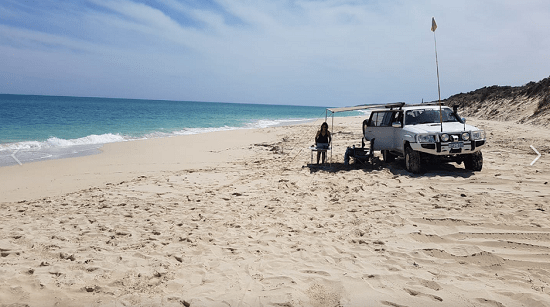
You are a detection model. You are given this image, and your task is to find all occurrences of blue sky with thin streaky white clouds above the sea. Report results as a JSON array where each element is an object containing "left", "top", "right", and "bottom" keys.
[{"left": 0, "top": 0, "right": 550, "bottom": 106}]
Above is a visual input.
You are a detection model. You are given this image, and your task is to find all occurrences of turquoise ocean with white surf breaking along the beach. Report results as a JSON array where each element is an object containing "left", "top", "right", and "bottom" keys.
[{"left": 0, "top": 94, "right": 361, "bottom": 166}]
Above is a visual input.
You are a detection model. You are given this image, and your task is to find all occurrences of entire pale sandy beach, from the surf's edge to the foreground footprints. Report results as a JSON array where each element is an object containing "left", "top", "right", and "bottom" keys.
[{"left": 0, "top": 117, "right": 550, "bottom": 307}]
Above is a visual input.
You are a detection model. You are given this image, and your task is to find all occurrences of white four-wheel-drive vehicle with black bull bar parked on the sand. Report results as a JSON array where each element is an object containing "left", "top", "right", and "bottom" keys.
[{"left": 363, "top": 103, "right": 485, "bottom": 173}]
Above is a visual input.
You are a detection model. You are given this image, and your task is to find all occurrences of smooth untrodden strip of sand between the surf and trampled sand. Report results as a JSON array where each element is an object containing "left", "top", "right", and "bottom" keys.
[{"left": 0, "top": 128, "right": 298, "bottom": 203}]
